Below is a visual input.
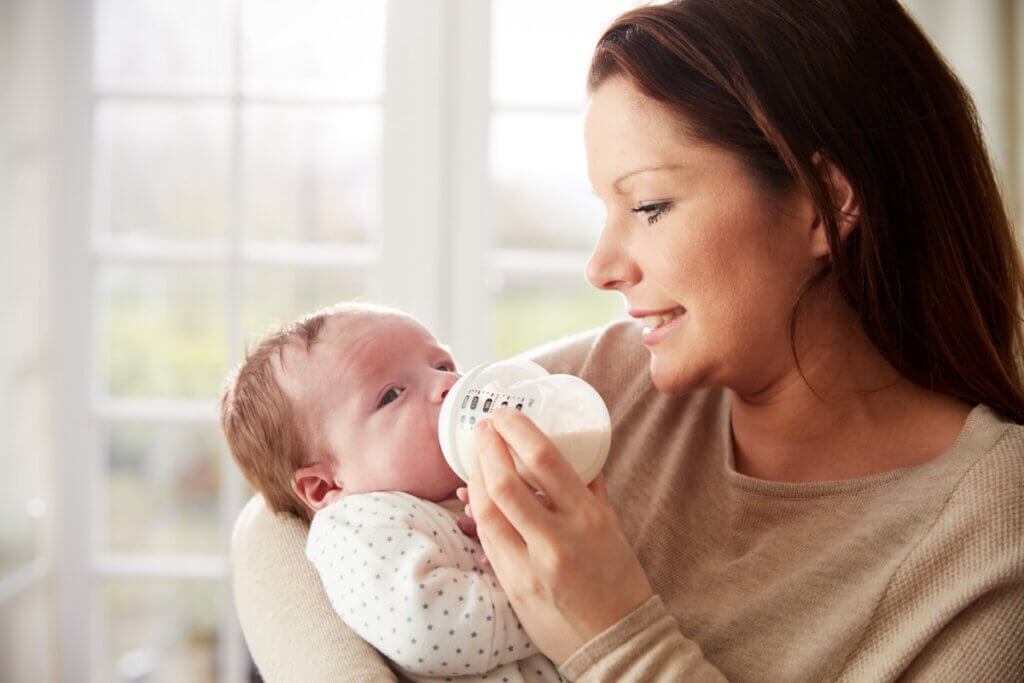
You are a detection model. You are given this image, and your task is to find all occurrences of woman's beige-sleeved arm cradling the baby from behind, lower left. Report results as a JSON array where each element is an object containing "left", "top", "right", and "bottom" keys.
[{"left": 231, "top": 497, "right": 398, "bottom": 683}]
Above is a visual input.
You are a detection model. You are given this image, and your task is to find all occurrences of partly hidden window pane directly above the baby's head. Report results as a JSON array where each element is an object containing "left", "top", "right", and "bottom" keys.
[{"left": 243, "top": 265, "right": 367, "bottom": 343}]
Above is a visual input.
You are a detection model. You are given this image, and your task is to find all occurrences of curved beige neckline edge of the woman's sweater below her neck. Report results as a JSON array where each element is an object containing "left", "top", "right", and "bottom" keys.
[{"left": 720, "top": 392, "right": 1006, "bottom": 499}]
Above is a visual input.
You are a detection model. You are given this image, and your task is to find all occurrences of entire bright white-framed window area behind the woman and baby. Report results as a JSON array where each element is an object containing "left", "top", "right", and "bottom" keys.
[{"left": 54, "top": 0, "right": 629, "bottom": 681}]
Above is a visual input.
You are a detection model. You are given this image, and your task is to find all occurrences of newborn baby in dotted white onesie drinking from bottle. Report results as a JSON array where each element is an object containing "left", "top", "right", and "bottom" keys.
[{"left": 221, "top": 303, "right": 562, "bottom": 681}]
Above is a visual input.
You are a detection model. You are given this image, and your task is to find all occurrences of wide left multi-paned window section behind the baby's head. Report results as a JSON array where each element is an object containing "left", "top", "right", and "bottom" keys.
[{"left": 83, "top": 0, "right": 387, "bottom": 681}]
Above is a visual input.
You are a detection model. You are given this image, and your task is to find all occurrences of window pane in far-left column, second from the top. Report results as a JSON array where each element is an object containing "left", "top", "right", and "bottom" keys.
[{"left": 94, "top": 102, "right": 227, "bottom": 241}]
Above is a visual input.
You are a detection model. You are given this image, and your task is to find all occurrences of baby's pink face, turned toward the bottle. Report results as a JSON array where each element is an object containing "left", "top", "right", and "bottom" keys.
[{"left": 283, "top": 313, "right": 462, "bottom": 501}]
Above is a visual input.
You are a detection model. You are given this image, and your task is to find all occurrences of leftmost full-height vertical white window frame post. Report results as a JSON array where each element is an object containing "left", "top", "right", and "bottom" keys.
[{"left": 52, "top": 0, "right": 101, "bottom": 681}]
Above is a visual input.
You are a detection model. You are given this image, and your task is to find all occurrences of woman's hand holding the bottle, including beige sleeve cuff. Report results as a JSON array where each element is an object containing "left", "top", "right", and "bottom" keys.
[{"left": 469, "top": 411, "right": 724, "bottom": 681}]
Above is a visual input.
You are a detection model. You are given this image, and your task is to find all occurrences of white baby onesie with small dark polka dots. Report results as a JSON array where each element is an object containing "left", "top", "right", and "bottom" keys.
[{"left": 306, "top": 492, "right": 563, "bottom": 683}]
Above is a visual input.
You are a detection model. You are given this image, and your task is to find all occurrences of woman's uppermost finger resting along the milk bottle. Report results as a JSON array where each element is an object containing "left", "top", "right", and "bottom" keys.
[{"left": 490, "top": 409, "right": 587, "bottom": 508}]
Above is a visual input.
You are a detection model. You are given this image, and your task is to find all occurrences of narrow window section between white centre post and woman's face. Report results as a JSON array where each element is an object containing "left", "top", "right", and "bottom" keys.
[{"left": 488, "top": 0, "right": 639, "bottom": 357}]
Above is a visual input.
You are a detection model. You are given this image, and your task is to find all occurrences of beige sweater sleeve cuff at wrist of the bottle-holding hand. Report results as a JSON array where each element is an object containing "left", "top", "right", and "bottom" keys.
[{"left": 558, "top": 595, "right": 726, "bottom": 682}]
